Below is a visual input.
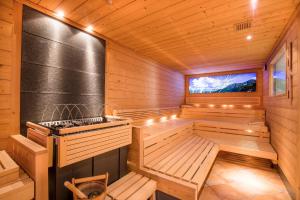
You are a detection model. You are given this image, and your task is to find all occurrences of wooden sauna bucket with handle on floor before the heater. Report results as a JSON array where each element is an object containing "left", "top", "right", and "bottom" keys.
[{"left": 64, "top": 173, "right": 108, "bottom": 200}]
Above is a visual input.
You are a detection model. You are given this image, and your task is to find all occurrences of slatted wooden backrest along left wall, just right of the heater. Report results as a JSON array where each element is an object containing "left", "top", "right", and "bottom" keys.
[{"left": 113, "top": 107, "right": 180, "bottom": 125}]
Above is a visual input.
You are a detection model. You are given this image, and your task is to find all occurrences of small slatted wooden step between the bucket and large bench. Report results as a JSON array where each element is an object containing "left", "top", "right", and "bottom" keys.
[{"left": 105, "top": 172, "right": 157, "bottom": 200}]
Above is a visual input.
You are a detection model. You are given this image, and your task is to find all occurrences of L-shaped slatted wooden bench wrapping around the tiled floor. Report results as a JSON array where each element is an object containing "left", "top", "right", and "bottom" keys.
[{"left": 128, "top": 119, "right": 277, "bottom": 200}]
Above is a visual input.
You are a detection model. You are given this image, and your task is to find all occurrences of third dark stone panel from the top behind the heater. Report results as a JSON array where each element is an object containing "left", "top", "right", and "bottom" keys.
[{"left": 21, "top": 62, "right": 104, "bottom": 95}]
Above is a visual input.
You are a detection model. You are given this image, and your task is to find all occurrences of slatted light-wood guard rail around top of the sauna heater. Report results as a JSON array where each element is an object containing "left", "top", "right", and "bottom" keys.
[{"left": 26, "top": 118, "right": 132, "bottom": 167}]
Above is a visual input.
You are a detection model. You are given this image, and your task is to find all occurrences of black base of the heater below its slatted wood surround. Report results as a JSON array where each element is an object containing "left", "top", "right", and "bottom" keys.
[{"left": 49, "top": 147, "right": 128, "bottom": 200}]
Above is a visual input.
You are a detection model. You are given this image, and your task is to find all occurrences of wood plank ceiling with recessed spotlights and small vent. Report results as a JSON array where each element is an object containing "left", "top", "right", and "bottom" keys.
[{"left": 25, "top": 0, "right": 299, "bottom": 73}]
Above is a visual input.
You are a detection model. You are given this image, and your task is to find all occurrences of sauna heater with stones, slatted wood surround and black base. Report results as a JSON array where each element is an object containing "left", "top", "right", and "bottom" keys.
[{"left": 26, "top": 113, "right": 132, "bottom": 200}]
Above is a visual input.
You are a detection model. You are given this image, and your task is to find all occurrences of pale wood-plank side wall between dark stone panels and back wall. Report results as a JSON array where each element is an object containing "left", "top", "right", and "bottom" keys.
[{"left": 106, "top": 42, "right": 184, "bottom": 109}]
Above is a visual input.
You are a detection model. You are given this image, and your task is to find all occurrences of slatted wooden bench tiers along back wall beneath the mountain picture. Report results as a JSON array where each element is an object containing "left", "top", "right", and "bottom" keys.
[{"left": 180, "top": 106, "right": 277, "bottom": 164}]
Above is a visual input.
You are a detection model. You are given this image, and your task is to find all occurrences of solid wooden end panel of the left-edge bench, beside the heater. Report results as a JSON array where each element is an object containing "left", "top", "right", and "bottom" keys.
[{"left": 0, "top": 135, "right": 48, "bottom": 200}]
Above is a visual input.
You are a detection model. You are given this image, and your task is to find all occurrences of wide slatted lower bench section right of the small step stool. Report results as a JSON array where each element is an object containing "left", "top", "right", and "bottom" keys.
[{"left": 131, "top": 135, "right": 219, "bottom": 200}]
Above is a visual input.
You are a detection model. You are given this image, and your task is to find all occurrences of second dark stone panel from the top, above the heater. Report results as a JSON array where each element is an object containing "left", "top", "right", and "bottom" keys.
[{"left": 22, "top": 32, "right": 104, "bottom": 73}]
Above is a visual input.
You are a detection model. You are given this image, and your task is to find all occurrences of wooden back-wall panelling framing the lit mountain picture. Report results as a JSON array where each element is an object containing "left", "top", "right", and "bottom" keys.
[{"left": 185, "top": 68, "right": 263, "bottom": 107}]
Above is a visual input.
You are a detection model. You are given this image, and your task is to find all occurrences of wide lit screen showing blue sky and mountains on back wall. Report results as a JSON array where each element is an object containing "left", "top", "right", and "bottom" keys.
[{"left": 188, "top": 72, "right": 256, "bottom": 94}]
